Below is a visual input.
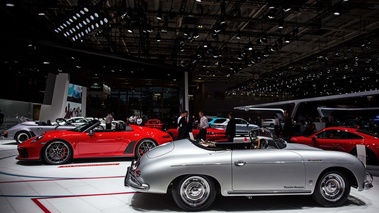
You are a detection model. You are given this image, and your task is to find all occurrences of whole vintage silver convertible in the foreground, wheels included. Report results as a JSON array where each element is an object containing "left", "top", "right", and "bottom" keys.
[{"left": 124, "top": 128, "right": 373, "bottom": 211}]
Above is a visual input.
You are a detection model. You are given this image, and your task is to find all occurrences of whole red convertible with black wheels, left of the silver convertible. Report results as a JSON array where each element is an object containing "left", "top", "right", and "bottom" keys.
[{"left": 16, "top": 120, "right": 173, "bottom": 165}]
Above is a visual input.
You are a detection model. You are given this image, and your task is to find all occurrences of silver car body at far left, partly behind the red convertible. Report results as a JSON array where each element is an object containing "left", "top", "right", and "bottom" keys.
[{"left": 3, "top": 121, "right": 75, "bottom": 143}]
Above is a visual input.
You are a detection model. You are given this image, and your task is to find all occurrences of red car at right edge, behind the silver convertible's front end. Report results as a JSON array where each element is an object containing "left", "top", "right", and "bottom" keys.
[{"left": 290, "top": 126, "right": 379, "bottom": 164}]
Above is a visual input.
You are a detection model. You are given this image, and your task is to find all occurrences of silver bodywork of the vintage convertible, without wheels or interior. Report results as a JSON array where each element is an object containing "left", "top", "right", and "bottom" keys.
[{"left": 125, "top": 136, "right": 366, "bottom": 196}]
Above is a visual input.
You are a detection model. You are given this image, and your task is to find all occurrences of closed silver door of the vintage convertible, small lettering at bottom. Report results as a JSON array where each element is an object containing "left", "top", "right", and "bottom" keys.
[{"left": 232, "top": 149, "right": 305, "bottom": 193}]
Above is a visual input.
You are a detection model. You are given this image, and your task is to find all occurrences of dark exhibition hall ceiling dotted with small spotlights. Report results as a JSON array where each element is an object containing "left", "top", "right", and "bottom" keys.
[{"left": 0, "top": 0, "right": 379, "bottom": 98}]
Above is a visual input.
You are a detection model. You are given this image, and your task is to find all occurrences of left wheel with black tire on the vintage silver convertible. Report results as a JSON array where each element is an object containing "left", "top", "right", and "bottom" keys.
[{"left": 171, "top": 175, "right": 217, "bottom": 211}]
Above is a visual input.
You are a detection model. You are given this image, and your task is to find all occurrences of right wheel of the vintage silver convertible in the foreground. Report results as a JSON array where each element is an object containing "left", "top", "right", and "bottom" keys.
[{"left": 312, "top": 171, "right": 350, "bottom": 207}]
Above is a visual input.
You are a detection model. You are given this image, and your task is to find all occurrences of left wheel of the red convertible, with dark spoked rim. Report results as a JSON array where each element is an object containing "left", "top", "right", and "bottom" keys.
[{"left": 42, "top": 141, "right": 72, "bottom": 165}]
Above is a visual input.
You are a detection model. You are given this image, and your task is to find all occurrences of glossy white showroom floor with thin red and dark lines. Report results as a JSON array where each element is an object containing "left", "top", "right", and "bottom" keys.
[{"left": 0, "top": 139, "right": 379, "bottom": 213}]
